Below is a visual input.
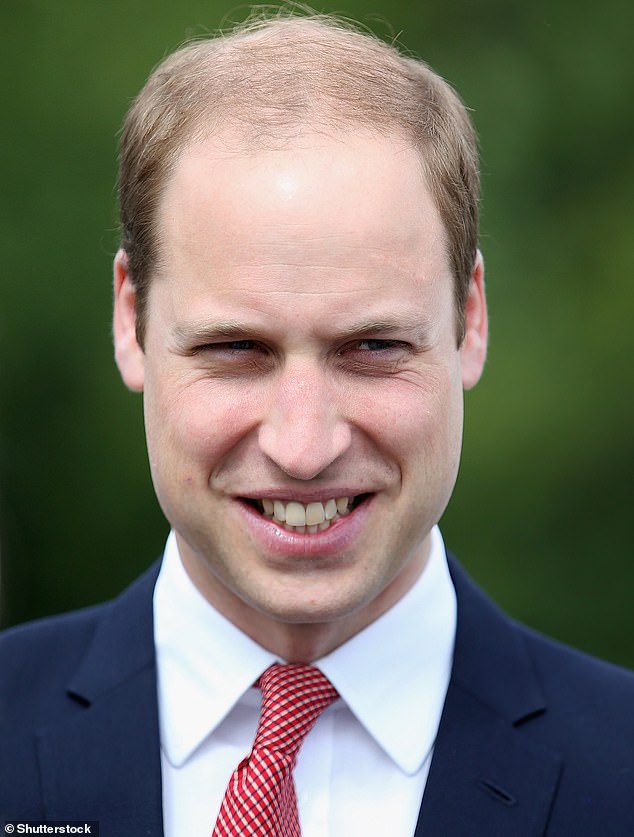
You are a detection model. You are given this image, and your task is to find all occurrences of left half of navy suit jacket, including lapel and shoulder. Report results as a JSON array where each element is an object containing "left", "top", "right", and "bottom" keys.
[{"left": 0, "top": 565, "right": 160, "bottom": 834}]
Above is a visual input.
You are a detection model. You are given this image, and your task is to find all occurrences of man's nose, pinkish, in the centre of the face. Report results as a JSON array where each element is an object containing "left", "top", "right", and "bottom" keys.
[{"left": 258, "top": 363, "right": 351, "bottom": 480}]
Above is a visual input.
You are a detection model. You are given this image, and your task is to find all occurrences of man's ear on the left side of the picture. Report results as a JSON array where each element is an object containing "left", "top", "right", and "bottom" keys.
[{"left": 112, "top": 250, "right": 145, "bottom": 392}]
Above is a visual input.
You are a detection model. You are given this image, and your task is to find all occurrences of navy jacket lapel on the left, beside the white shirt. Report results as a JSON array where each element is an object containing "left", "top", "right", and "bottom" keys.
[{"left": 36, "top": 566, "right": 163, "bottom": 837}]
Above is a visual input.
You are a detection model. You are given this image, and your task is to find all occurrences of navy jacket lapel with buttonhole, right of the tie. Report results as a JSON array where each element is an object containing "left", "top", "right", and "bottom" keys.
[{"left": 415, "top": 564, "right": 561, "bottom": 837}]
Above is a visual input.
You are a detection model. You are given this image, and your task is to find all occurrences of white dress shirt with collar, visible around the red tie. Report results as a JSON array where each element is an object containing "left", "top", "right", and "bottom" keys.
[{"left": 154, "top": 528, "right": 456, "bottom": 837}]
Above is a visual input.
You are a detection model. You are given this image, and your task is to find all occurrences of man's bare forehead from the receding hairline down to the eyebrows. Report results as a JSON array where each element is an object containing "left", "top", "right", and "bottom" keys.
[{"left": 151, "top": 132, "right": 450, "bottom": 326}]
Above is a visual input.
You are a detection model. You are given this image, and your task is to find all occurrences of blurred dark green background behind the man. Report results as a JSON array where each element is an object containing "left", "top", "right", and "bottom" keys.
[{"left": 0, "top": 0, "right": 634, "bottom": 666}]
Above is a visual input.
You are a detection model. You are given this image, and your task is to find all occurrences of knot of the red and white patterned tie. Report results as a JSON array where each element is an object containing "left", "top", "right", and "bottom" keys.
[{"left": 253, "top": 663, "right": 337, "bottom": 757}]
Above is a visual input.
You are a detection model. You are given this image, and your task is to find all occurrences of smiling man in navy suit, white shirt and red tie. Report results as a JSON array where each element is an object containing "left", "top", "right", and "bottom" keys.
[{"left": 0, "top": 9, "right": 634, "bottom": 837}]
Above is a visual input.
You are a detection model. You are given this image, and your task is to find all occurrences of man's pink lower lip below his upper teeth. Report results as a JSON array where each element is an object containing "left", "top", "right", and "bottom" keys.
[{"left": 237, "top": 495, "right": 373, "bottom": 558}]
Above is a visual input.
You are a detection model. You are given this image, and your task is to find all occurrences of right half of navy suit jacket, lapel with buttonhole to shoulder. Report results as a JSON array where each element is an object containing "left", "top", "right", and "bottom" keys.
[{"left": 436, "top": 561, "right": 634, "bottom": 837}]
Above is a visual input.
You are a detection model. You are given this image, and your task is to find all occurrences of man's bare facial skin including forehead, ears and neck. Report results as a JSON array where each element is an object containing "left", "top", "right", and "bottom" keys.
[{"left": 114, "top": 132, "right": 487, "bottom": 662}]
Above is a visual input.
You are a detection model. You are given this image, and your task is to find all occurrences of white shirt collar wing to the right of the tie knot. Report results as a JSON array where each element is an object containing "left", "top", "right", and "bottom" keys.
[{"left": 316, "top": 527, "right": 457, "bottom": 774}]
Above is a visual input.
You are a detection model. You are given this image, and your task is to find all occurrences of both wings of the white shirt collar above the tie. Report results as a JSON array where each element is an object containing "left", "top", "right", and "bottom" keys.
[{"left": 154, "top": 527, "right": 456, "bottom": 774}]
